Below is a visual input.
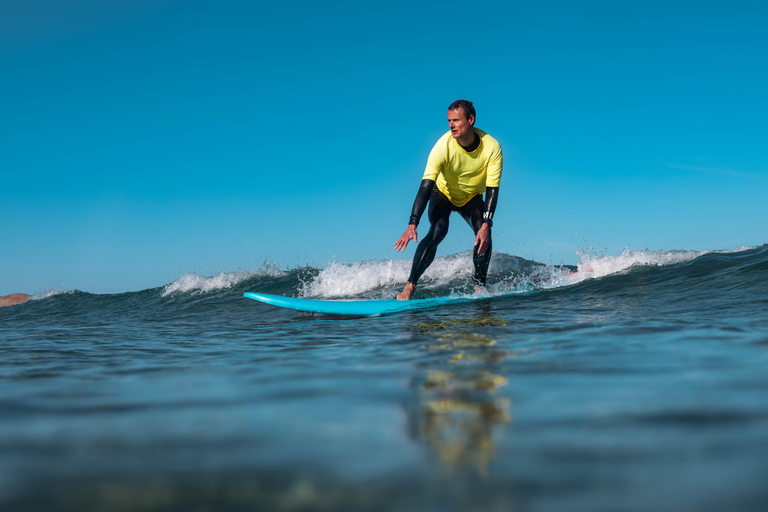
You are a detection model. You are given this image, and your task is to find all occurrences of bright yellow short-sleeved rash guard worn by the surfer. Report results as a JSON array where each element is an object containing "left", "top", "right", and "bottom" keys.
[{"left": 422, "top": 128, "right": 503, "bottom": 206}]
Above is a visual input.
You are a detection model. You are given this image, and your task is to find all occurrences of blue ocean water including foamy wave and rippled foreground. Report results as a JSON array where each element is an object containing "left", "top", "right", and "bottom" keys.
[{"left": 0, "top": 246, "right": 768, "bottom": 512}]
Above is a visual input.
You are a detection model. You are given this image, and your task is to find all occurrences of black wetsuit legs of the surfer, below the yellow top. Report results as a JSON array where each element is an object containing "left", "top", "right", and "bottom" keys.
[{"left": 408, "top": 187, "right": 491, "bottom": 286}]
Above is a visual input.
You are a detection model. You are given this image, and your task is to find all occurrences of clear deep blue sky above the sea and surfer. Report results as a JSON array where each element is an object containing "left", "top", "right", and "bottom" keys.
[{"left": 0, "top": 0, "right": 768, "bottom": 295}]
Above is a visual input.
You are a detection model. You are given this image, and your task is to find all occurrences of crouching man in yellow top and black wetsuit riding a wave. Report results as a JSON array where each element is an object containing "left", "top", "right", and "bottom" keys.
[{"left": 395, "top": 100, "right": 503, "bottom": 300}]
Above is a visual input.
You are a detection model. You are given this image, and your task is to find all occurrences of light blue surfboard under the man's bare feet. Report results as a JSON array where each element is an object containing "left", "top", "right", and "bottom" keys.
[{"left": 243, "top": 292, "right": 480, "bottom": 316}]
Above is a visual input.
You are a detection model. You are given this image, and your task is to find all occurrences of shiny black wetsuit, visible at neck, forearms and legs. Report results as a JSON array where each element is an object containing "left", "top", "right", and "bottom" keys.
[{"left": 408, "top": 136, "right": 499, "bottom": 286}]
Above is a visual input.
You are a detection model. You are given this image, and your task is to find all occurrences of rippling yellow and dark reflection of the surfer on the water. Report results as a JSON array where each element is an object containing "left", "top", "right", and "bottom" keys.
[{"left": 410, "top": 315, "right": 514, "bottom": 476}]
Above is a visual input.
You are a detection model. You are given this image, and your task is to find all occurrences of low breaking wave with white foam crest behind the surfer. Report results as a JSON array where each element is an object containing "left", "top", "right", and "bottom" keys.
[{"left": 4, "top": 243, "right": 768, "bottom": 314}]
